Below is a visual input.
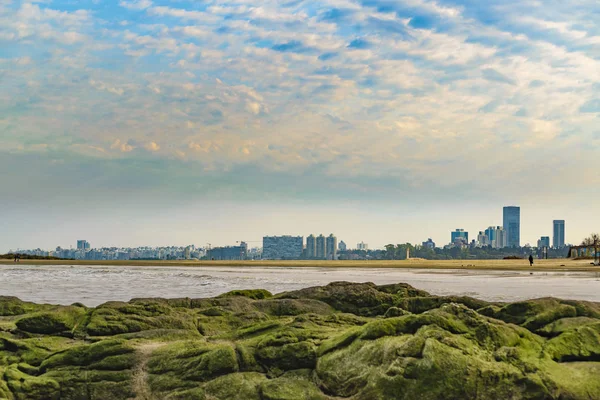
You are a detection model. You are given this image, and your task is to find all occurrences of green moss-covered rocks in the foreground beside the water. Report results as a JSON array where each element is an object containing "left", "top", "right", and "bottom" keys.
[{"left": 0, "top": 282, "right": 600, "bottom": 400}]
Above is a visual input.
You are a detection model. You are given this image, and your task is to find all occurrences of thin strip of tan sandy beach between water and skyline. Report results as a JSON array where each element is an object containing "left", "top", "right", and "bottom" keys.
[{"left": 0, "top": 259, "right": 600, "bottom": 272}]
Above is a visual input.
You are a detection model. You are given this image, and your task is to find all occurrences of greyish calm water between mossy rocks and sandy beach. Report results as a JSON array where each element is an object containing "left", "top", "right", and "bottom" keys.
[{"left": 0, "top": 264, "right": 600, "bottom": 306}]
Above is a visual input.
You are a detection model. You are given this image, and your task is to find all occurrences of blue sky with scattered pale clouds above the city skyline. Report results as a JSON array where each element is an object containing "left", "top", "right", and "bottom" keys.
[{"left": 0, "top": 0, "right": 600, "bottom": 251}]
